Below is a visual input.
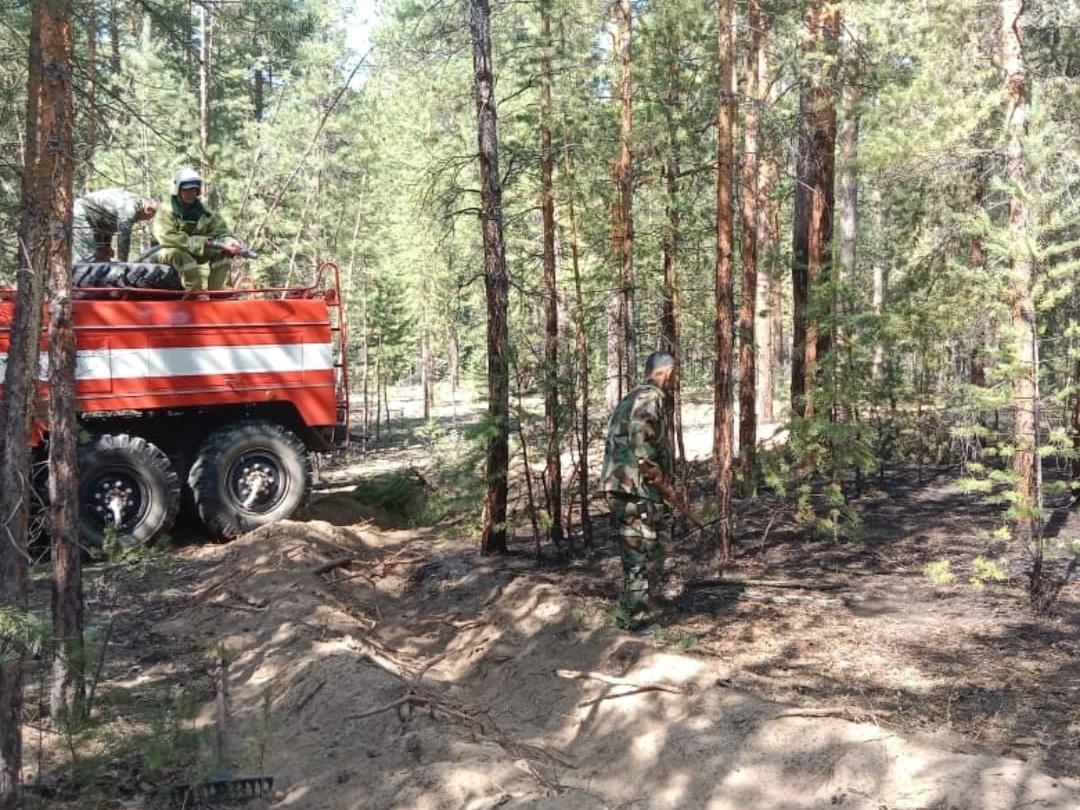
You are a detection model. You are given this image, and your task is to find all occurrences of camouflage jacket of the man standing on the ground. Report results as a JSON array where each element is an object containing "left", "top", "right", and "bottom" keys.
[{"left": 600, "top": 381, "right": 674, "bottom": 501}]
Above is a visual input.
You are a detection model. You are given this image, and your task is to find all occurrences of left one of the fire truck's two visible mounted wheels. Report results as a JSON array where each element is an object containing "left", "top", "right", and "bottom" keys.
[{"left": 79, "top": 433, "right": 180, "bottom": 549}]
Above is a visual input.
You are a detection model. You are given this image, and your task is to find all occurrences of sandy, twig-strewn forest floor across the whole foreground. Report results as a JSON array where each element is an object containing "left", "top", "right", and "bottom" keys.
[{"left": 24, "top": 390, "right": 1080, "bottom": 810}]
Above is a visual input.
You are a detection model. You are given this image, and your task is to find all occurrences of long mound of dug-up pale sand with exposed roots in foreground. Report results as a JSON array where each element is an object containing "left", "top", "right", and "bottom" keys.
[{"left": 160, "top": 520, "right": 1080, "bottom": 810}]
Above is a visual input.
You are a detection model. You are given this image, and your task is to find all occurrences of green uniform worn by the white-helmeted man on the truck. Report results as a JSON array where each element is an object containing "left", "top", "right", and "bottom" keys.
[{"left": 150, "top": 197, "right": 235, "bottom": 289}]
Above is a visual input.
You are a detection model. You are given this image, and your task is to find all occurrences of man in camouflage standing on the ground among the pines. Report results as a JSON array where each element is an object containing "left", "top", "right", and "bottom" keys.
[{"left": 600, "top": 352, "right": 675, "bottom": 627}]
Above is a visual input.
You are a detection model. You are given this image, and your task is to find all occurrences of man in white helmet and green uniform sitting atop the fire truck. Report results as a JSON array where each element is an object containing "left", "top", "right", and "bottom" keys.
[{"left": 150, "top": 166, "right": 241, "bottom": 293}]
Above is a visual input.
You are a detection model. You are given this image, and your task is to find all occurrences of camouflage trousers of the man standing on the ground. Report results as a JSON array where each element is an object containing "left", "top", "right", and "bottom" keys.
[{"left": 608, "top": 495, "right": 672, "bottom": 613}]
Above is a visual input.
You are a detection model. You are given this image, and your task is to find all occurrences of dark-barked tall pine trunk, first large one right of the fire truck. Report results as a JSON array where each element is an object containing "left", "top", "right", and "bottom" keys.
[{"left": 469, "top": 0, "right": 510, "bottom": 554}]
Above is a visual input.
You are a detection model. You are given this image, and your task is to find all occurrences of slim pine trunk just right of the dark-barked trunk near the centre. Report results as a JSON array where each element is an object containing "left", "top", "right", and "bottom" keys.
[{"left": 540, "top": 0, "right": 563, "bottom": 548}]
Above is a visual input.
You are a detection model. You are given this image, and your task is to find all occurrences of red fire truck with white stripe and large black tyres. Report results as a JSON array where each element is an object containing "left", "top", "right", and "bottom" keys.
[{"left": 0, "top": 262, "right": 349, "bottom": 546}]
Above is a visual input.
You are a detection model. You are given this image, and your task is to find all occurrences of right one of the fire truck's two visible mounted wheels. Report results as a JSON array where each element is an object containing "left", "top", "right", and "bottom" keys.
[{"left": 188, "top": 419, "right": 311, "bottom": 537}]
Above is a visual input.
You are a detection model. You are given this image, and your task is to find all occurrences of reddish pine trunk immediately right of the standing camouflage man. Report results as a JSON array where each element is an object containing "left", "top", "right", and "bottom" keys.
[{"left": 713, "top": 0, "right": 735, "bottom": 559}]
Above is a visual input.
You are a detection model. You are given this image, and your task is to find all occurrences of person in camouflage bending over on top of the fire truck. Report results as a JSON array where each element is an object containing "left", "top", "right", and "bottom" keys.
[{"left": 71, "top": 188, "right": 158, "bottom": 261}]
